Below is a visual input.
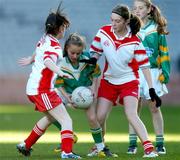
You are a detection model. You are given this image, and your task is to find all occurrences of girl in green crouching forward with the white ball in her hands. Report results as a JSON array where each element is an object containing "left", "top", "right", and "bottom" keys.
[{"left": 55, "top": 33, "right": 117, "bottom": 157}]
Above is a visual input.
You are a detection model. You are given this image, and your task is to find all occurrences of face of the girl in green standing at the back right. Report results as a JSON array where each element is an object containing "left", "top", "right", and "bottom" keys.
[{"left": 132, "top": 1, "right": 150, "bottom": 20}]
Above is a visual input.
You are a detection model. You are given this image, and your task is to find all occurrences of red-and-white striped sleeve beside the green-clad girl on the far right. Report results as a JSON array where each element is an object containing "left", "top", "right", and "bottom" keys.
[{"left": 134, "top": 42, "right": 150, "bottom": 68}]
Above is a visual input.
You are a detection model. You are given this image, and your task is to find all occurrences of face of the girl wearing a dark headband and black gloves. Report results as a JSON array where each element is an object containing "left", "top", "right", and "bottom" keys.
[{"left": 111, "top": 13, "right": 127, "bottom": 33}]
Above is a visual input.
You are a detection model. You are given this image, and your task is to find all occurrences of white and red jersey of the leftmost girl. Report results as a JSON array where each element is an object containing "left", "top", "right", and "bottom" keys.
[{"left": 26, "top": 35, "right": 63, "bottom": 95}]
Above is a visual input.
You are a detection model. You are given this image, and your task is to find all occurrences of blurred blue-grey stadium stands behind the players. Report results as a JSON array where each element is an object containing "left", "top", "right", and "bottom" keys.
[{"left": 0, "top": 0, "right": 180, "bottom": 104}]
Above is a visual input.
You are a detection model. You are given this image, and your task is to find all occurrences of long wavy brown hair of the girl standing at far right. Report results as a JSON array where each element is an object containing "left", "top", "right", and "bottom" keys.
[{"left": 135, "top": 0, "right": 169, "bottom": 34}]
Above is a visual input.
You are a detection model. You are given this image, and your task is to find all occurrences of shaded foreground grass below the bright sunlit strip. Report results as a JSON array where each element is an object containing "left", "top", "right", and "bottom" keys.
[{"left": 0, "top": 143, "right": 180, "bottom": 160}]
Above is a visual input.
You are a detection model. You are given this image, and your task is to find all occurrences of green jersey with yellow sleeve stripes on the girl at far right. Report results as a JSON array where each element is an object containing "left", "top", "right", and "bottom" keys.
[{"left": 138, "top": 20, "right": 170, "bottom": 83}]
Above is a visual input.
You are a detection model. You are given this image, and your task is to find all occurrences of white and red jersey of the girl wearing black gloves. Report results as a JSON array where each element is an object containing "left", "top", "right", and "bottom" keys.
[{"left": 90, "top": 25, "right": 149, "bottom": 85}]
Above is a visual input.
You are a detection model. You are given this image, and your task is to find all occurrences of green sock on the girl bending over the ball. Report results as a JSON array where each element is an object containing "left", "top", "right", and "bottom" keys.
[{"left": 90, "top": 128, "right": 102, "bottom": 144}]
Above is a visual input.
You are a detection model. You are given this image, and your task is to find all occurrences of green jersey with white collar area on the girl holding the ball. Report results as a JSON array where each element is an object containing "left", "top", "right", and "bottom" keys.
[{"left": 55, "top": 52, "right": 101, "bottom": 94}]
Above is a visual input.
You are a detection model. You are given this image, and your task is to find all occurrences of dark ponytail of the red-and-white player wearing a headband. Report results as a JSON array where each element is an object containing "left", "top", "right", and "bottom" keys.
[{"left": 129, "top": 14, "right": 141, "bottom": 35}]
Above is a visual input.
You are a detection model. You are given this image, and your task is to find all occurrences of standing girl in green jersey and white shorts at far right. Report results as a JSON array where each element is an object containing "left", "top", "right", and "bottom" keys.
[{"left": 127, "top": 0, "right": 170, "bottom": 154}]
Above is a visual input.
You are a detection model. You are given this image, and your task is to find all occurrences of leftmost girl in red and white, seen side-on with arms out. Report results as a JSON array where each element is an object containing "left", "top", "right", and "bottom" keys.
[{"left": 16, "top": 6, "right": 81, "bottom": 159}]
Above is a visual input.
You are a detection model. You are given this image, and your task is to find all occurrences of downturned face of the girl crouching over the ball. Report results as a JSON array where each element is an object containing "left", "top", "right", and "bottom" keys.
[{"left": 67, "top": 44, "right": 83, "bottom": 64}]
